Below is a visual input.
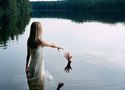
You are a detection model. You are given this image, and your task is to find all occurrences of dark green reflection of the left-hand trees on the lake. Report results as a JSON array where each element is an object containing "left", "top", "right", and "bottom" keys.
[{"left": 0, "top": 13, "right": 30, "bottom": 48}]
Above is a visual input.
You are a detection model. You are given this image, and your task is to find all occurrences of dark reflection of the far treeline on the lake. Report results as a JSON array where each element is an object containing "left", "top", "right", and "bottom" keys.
[{"left": 32, "top": 10, "right": 125, "bottom": 24}]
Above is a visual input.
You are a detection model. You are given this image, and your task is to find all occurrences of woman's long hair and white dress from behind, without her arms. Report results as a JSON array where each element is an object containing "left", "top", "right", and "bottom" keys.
[{"left": 27, "top": 22, "right": 44, "bottom": 79}]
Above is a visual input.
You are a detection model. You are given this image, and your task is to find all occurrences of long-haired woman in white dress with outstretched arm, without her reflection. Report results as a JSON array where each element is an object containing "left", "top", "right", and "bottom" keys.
[{"left": 26, "top": 22, "right": 63, "bottom": 80}]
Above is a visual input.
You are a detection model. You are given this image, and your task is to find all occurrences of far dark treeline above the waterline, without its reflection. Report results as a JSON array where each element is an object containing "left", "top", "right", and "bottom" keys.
[{"left": 31, "top": 0, "right": 125, "bottom": 12}]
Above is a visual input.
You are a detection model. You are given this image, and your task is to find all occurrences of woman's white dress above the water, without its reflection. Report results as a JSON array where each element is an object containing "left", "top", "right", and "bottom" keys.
[{"left": 29, "top": 46, "right": 44, "bottom": 80}]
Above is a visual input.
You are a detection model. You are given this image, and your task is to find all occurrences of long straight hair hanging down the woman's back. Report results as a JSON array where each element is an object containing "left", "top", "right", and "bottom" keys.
[{"left": 27, "top": 22, "right": 42, "bottom": 48}]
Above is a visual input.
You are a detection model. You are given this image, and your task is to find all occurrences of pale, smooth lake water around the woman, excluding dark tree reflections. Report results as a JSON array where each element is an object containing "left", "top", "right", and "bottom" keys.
[{"left": 0, "top": 18, "right": 125, "bottom": 90}]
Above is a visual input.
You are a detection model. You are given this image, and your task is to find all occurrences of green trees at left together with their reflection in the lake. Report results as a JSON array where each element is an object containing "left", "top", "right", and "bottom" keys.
[{"left": 0, "top": 0, "right": 31, "bottom": 48}]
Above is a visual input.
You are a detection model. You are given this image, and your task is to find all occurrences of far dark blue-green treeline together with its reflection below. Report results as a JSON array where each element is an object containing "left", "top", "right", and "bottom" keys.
[{"left": 31, "top": 0, "right": 125, "bottom": 24}]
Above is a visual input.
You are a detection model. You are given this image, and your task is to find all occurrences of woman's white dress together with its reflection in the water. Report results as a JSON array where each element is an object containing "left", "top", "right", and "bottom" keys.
[{"left": 27, "top": 46, "right": 45, "bottom": 90}]
